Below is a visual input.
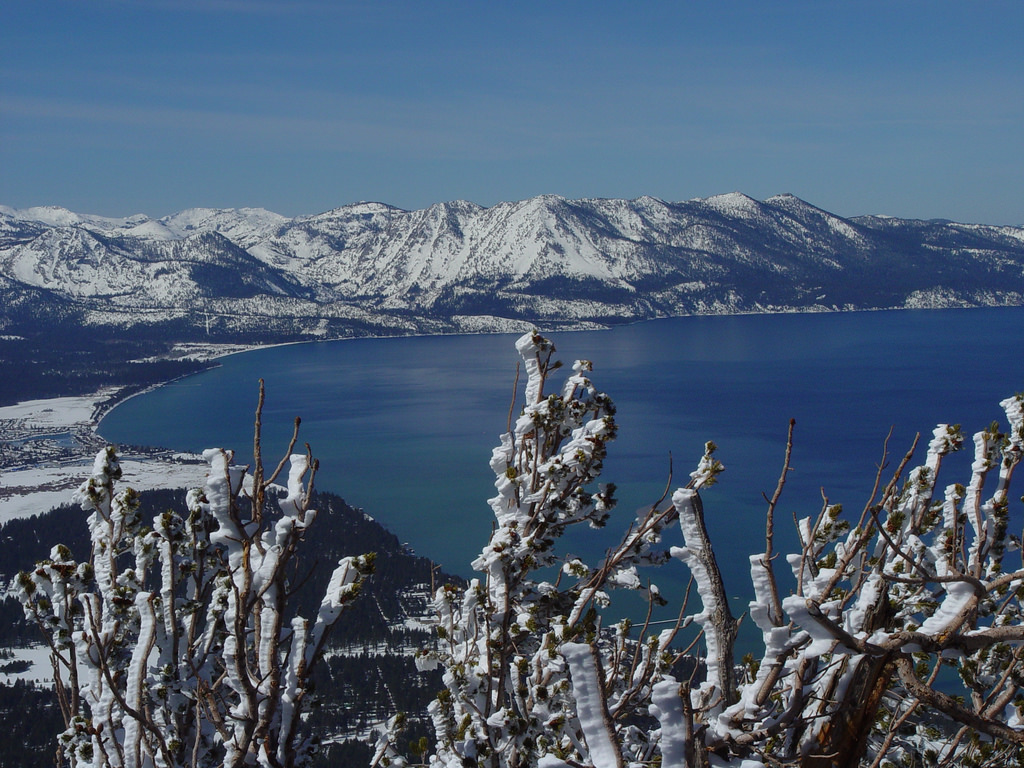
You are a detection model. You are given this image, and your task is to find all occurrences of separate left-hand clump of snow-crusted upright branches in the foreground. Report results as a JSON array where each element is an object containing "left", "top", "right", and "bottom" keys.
[{"left": 19, "top": 388, "right": 372, "bottom": 768}]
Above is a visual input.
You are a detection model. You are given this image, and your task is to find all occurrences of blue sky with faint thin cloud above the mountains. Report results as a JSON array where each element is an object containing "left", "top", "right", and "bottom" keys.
[{"left": 0, "top": 0, "right": 1024, "bottom": 225}]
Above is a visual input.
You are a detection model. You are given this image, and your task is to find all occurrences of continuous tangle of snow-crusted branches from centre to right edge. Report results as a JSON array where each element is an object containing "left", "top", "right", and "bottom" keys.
[{"left": 407, "top": 334, "right": 1024, "bottom": 768}]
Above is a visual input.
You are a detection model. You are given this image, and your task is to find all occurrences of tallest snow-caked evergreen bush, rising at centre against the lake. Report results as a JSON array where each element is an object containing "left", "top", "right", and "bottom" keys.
[{"left": 407, "top": 333, "right": 696, "bottom": 768}]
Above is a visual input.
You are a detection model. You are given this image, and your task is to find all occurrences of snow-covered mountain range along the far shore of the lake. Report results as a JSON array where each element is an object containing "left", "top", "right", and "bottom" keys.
[{"left": 0, "top": 193, "right": 1024, "bottom": 336}]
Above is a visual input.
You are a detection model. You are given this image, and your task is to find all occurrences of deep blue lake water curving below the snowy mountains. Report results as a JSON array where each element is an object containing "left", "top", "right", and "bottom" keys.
[{"left": 100, "top": 307, "right": 1024, "bottom": 612}]
